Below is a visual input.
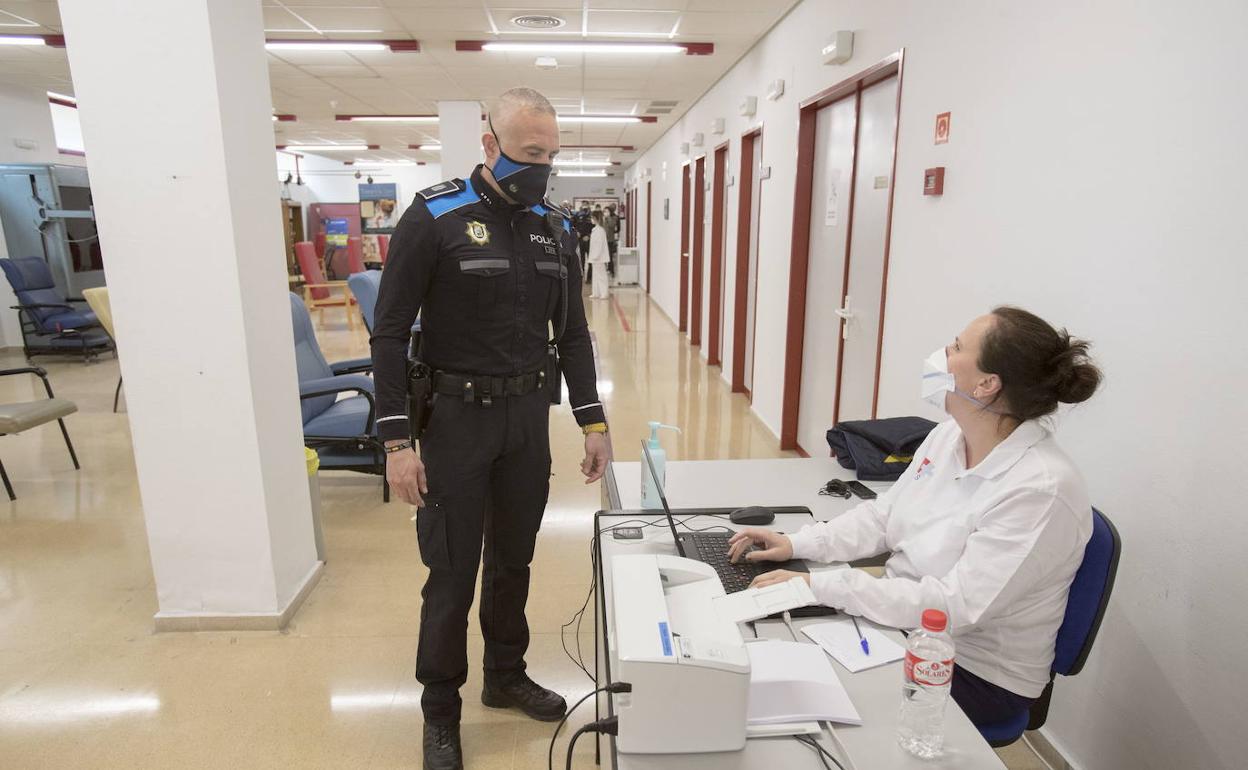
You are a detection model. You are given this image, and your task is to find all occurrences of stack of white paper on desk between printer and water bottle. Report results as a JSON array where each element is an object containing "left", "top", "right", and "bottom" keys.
[{"left": 745, "top": 640, "right": 862, "bottom": 725}]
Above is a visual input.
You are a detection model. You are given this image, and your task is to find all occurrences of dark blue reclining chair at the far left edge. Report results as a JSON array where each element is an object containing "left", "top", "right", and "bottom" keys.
[{"left": 0, "top": 257, "right": 114, "bottom": 361}]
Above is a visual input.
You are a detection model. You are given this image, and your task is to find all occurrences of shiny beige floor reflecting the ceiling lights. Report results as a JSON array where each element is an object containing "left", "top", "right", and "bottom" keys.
[{"left": 0, "top": 290, "right": 1042, "bottom": 770}]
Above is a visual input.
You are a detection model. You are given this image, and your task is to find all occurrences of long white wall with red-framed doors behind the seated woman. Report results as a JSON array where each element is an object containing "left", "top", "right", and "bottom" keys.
[{"left": 630, "top": 0, "right": 1248, "bottom": 769}]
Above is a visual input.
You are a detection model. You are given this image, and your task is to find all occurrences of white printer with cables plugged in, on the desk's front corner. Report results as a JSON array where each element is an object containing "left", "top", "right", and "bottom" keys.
[{"left": 609, "top": 554, "right": 750, "bottom": 754}]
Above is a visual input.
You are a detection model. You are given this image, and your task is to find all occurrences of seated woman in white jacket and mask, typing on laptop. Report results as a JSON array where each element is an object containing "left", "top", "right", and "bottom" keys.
[{"left": 729, "top": 307, "right": 1101, "bottom": 724}]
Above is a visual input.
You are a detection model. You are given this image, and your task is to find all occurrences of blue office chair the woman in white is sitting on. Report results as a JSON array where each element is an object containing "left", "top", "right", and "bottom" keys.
[{"left": 975, "top": 508, "right": 1122, "bottom": 748}]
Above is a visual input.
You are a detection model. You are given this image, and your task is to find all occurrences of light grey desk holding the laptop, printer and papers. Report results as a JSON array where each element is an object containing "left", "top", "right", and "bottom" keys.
[{"left": 594, "top": 458, "right": 1003, "bottom": 770}]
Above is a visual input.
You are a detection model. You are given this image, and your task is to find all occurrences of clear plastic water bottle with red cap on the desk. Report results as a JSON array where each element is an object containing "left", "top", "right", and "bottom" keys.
[{"left": 897, "top": 609, "right": 953, "bottom": 759}]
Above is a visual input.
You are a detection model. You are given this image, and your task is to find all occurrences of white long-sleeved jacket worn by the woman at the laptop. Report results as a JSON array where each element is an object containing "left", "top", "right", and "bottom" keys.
[{"left": 790, "top": 421, "right": 1092, "bottom": 698}]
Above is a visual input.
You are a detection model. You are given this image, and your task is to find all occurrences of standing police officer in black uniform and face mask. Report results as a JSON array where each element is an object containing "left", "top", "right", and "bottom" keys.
[{"left": 372, "top": 89, "right": 607, "bottom": 770}]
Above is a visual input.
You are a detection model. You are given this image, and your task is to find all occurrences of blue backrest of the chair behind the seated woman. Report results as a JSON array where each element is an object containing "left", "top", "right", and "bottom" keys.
[{"left": 1053, "top": 508, "right": 1122, "bottom": 676}]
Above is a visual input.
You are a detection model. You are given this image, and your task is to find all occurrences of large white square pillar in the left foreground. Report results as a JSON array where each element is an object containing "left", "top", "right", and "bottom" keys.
[{"left": 60, "top": 0, "right": 321, "bottom": 629}]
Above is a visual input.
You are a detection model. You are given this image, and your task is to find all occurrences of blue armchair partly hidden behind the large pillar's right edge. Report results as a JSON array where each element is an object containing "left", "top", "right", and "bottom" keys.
[{"left": 291, "top": 293, "right": 389, "bottom": 503}]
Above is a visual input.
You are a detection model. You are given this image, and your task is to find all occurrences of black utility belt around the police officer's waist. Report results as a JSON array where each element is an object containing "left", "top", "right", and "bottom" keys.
[{"left": 407, "top": 344, "right": 563, "bottom": 441}]
